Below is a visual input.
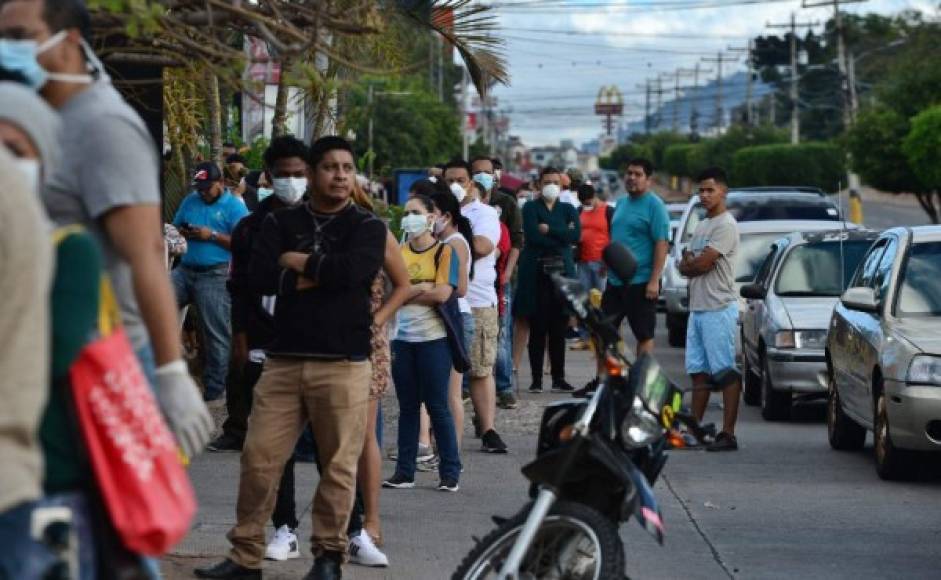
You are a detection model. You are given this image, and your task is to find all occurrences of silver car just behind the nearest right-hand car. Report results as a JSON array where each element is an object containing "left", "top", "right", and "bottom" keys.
[{"left": 741, "top": 230, "right": 879, "bottom": 421}]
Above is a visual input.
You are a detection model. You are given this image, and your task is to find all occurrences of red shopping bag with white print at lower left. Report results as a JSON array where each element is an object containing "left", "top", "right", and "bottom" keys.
[{"left": 70, "top": 279, "right": 196, "bottom": 556}]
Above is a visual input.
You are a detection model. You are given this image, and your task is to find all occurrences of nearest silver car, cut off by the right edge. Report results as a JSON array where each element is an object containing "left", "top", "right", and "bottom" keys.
[{"left": 826, "top": 226, "right": 941, "bottom": 479}]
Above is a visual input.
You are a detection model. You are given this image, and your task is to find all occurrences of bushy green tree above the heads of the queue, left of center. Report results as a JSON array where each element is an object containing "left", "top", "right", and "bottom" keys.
[{"left": 340, "top": 76, "right": 461, "bottom": 175}]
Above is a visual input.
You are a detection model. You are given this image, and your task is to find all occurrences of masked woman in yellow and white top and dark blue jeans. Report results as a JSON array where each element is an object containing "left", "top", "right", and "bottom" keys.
[{"left": 382, "top": 195, "right": 461, "bottom": 491}]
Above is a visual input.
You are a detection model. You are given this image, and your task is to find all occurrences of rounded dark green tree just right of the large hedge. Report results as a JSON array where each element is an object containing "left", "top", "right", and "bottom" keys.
[{"left": 846, "top": 107, "right": 925, "bottom": 193}]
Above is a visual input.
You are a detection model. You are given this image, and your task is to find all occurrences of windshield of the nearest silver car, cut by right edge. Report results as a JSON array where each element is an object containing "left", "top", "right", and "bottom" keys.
[{"left": 897, "top": 242, "right": 941, "bottom": 316}]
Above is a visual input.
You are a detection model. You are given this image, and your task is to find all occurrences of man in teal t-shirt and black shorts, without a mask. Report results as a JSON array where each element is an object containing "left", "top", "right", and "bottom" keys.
[{"left": 601, "top": 159, "right": 670, "bottom": 355}]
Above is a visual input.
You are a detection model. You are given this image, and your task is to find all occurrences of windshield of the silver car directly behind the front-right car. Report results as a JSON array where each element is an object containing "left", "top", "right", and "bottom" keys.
[{"left": 774, "top": 240, "right": 872, "bottom": 296}]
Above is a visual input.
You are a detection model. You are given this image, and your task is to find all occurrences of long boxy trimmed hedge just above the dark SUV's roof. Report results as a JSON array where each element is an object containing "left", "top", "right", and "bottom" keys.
[{"left": 731, "top": 143, "right": 846, "bottom": 191}]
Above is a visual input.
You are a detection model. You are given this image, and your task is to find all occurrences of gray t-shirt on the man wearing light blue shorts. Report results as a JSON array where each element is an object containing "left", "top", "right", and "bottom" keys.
[{"left": 689, "top": 212, "right": 738, "bottom": 312}]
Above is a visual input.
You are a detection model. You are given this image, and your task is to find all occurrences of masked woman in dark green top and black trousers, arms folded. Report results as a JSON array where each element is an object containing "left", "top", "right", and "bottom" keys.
[{"left": 514, "top": 167, "right": 581, "bottom": 393}]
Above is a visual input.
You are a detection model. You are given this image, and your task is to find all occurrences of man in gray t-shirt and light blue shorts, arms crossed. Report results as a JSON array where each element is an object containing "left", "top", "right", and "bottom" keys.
[{"left": 679, "top": 167, "right": 742, "bottom": 451}]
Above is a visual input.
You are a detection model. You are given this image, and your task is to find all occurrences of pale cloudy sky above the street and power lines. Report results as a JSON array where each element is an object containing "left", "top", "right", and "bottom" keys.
[{"left": 493, "top": 0, "right": 939, "bottom": 146}]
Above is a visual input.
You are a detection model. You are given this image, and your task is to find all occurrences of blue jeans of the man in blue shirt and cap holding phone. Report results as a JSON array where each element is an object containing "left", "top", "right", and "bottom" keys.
[{"left": 171, "top": 264, "right": 232, "bottom": 399}]
